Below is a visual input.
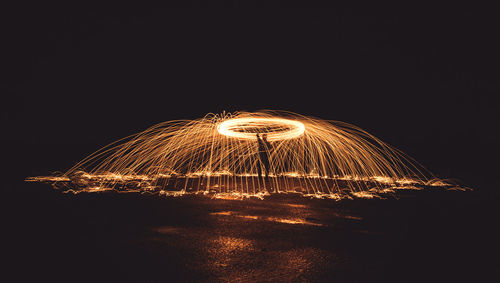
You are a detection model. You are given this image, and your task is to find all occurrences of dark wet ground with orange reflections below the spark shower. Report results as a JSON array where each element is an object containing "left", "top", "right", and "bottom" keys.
[{"left": 2, "top": 184, "right": 495, "bottom": 282}]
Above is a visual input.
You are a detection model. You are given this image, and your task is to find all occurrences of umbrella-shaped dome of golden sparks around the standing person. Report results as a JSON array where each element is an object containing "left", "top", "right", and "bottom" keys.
[{"left": 27, "top": 111, "right": 466, "bottom": 199}]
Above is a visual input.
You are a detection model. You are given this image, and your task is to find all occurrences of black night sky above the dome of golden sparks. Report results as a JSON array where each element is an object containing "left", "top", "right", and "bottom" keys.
[{"left": 0, "top": 1, "right": 500, "bottom": 191}]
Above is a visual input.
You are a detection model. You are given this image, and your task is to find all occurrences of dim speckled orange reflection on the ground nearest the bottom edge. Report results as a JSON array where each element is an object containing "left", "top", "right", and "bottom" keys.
[{"left": 204, "top": 239, "right": 332, "bottom": 282}]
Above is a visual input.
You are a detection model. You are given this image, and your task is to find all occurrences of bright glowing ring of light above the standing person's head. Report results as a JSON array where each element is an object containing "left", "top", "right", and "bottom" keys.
[{"left": 217, "top": 117, "right": 305, "bottom": 141}]
